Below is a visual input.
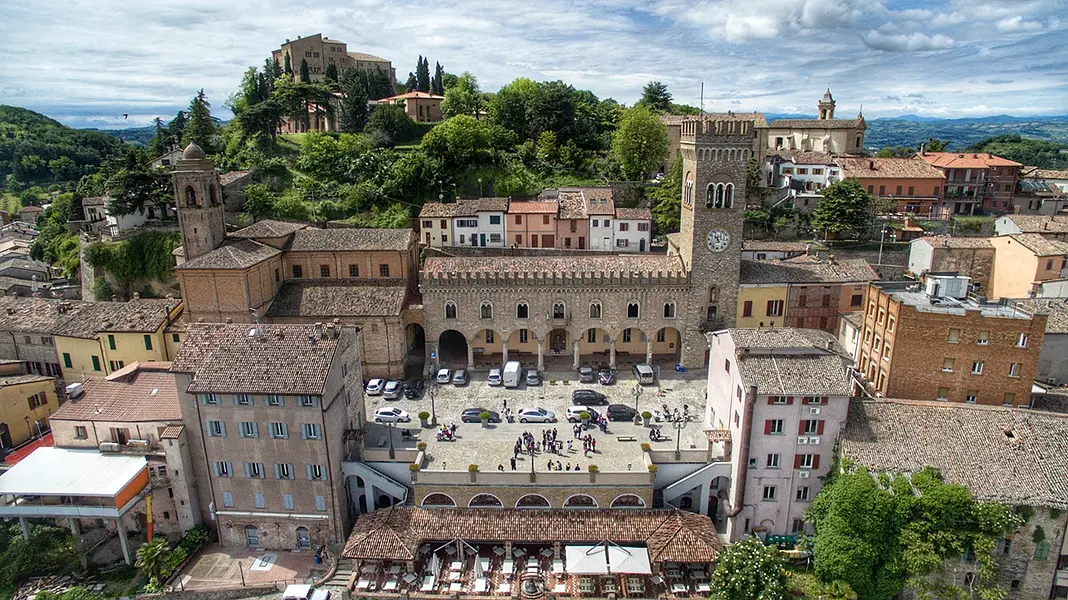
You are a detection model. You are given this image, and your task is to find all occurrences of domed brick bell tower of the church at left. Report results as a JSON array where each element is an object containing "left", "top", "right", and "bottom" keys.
[{"left": 172, "top": 144, "right": 226, "bottom": 262}]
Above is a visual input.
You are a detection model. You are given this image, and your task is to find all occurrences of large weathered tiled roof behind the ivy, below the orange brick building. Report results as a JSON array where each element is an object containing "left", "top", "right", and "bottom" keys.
[{"left": 839, "top": 400, "right": 1068, "bottom": 509}]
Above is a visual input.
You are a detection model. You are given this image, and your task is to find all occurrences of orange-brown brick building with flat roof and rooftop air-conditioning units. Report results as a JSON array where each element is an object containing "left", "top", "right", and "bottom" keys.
[{"left": 858, "top": 277, "right": 1047, "bottom": 406}]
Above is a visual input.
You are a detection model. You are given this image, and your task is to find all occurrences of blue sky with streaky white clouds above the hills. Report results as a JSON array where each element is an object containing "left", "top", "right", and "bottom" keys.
[{"left": 0, "top": 0, "right": 1068, "bottom": 127}]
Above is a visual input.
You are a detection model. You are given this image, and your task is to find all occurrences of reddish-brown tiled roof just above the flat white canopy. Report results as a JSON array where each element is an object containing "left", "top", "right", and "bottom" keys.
[{"left": 51, "top": 363, "right": 182, "bottom": 423}]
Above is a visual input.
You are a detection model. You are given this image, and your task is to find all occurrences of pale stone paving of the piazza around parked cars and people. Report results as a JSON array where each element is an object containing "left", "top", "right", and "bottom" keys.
[{"left": 366, "top": 370, "right": 707, "bottom": 472}]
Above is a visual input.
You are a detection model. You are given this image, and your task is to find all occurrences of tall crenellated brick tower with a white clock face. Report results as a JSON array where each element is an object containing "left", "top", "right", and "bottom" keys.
[{"left": 677, "top": 113, "right": 758, "bottom": 335}]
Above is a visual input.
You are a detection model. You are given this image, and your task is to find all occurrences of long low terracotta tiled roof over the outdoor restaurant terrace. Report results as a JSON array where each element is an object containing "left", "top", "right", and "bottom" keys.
[{"left": 342, "top": 506, "right": 722, "bottom": 564}]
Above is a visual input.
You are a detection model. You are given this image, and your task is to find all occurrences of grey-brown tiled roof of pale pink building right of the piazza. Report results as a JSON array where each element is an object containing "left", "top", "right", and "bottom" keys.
[{"left": 738, "top": 352, "right": 850, "bottom": 396}]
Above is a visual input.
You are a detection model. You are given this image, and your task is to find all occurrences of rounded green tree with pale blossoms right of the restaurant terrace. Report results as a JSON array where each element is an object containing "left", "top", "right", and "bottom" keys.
[{"left": 708, "top": 536, "right": 789, "bottom": 600}]
